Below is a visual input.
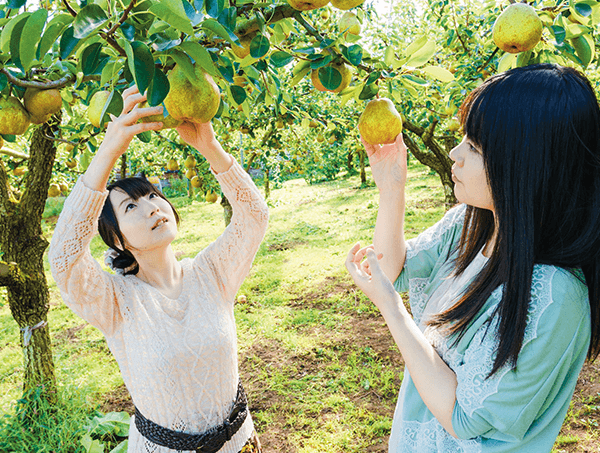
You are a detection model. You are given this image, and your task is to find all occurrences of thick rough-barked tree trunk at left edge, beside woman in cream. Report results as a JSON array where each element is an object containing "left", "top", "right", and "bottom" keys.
[{"left": 0, "top": 123, "right": 57, "bottom": 402}]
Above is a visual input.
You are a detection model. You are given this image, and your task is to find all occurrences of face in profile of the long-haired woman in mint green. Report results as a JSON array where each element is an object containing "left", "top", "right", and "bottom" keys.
[{"left": 450, "top": 135, "right": 494, "bottom": 212}]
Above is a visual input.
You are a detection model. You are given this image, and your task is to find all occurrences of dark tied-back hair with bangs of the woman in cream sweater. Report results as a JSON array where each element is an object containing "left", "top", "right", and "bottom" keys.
[{"left": 98, "top": 176, "right": 179, "bottom": 275}]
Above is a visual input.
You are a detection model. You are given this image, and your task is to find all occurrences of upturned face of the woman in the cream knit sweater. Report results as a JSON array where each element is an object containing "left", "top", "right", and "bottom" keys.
[{"left": 109, "top": 189, "right": 177, "bottom": 252}]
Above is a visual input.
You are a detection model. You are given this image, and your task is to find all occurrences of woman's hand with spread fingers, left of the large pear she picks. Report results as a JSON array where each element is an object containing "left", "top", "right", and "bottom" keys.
[{"left": 98, "top": 85, "right": 163, "bottom": 160}]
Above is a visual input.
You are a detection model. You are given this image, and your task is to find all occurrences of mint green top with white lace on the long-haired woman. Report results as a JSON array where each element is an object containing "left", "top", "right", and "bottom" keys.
[{"left": 389, "top": 205, "right": 591, "bottom": 453}]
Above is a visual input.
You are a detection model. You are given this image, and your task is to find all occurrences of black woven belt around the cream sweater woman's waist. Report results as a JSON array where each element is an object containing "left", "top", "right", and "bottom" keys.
[{"left": 135, "top": 382, "right": 248, "bottom": 453}]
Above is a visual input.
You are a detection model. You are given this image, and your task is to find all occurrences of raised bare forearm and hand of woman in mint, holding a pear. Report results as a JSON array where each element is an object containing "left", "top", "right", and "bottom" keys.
[{"left": 363, "top": 134, "right": 407, "bottom": 282}]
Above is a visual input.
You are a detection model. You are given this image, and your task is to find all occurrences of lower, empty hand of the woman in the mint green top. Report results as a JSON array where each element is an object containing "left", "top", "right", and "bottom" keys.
[{"left": 346, "top": 243, "right": 398, "bottom": 312}]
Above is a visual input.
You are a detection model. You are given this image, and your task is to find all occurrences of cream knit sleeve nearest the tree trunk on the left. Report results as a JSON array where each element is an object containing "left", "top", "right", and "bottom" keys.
[{"left": 48, "top": 179, "right": 121, "bottom": 335}]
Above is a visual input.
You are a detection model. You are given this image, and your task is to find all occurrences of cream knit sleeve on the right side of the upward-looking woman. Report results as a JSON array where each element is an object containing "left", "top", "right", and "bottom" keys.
[{"left": 194, "top": 160, "right": 269, "bottom": 301}]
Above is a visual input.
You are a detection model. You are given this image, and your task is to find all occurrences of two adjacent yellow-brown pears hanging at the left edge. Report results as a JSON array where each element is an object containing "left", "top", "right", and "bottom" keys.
[{"left": 0, "top": 88, "right": 62, "bottom": 135}]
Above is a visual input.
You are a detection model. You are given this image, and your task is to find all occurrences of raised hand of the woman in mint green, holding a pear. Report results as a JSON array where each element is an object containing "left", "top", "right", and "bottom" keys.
[{"left": 360, "top": 134, "right": 408, "bottom": 193}]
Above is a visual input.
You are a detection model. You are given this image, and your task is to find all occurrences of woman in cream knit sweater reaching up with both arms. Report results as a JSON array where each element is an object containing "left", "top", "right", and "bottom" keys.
[{"left": 49, "top": 87, "right": 268, "bottom": 453}]
